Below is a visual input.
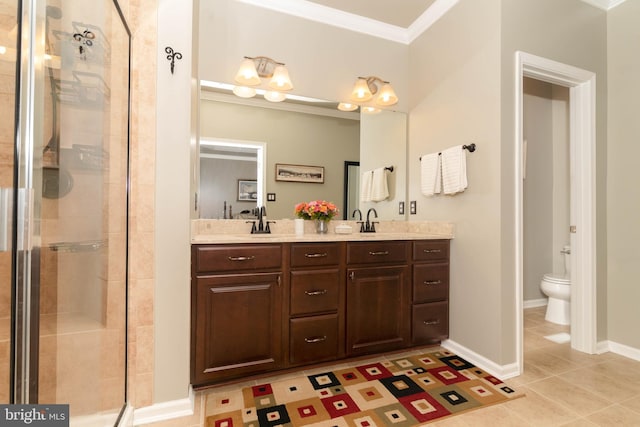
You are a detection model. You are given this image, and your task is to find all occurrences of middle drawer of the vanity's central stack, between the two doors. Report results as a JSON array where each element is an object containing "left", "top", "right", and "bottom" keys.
[{"left": 291, "top": 268, "right": 342, "bottom": 316}]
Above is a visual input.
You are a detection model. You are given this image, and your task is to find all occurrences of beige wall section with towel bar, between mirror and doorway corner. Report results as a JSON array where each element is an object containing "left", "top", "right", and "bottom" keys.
[{"left": 408, "top": 0, "right": 504, "bottom": 363}]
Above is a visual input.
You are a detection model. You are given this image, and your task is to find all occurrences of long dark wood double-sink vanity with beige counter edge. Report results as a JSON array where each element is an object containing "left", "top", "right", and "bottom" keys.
[{"left": 191, "top": 222, "right": 452, "bottom": 388}]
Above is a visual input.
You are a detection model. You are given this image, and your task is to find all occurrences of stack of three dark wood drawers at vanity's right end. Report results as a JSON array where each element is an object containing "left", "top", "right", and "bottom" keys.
[{"left": 411, "top": 240, "right": 449, "bottom": 345}]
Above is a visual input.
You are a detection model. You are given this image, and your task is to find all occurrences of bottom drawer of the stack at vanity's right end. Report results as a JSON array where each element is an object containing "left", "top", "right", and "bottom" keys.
[{"left": 412, "top": 301, "right": 449, "bottom": 345}]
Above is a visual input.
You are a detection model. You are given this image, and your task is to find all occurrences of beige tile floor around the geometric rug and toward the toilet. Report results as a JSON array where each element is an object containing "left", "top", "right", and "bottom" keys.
[{"left": 149, "top": 307, "right": 640, "bottom": 427}]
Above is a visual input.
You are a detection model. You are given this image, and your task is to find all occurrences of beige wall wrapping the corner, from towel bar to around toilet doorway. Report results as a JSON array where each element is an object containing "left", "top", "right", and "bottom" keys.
[{"left": 409, "top": 0, "right": 607, "bottom": 364}]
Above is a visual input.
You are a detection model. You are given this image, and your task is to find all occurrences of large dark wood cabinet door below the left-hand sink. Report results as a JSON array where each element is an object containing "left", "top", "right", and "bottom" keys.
[{"left": 191, "top": 273, "right": 283, "bottom": 386}]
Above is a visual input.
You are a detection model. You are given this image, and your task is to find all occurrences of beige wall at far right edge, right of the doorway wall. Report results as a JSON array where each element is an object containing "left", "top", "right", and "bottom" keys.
[{"left": 607, "top": 0, "right": 640, "bottom": 351}]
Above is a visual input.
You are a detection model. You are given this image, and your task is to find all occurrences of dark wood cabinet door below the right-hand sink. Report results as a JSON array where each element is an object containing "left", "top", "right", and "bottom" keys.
[{"left": 347, "top": 266, "right": 411, "bottom": 356}]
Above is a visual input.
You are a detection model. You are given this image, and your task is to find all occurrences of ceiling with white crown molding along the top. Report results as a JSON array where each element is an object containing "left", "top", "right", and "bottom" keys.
[{"left": 238, "top": 0, "right": 624, "bottom": 44}]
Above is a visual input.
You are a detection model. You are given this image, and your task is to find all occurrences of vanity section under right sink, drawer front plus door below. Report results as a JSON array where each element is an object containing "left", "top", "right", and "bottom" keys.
[{"left": 347, "top": 241, "right": 411, "bottom": 356}]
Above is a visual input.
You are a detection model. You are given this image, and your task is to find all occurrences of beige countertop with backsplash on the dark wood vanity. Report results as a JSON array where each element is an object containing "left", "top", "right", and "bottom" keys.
[{"left": 191, "top": 219, "right": 454, "bottom": 244}]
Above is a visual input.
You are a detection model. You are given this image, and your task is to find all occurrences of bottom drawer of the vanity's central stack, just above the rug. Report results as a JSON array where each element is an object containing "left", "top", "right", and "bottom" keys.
[{"left": 289, "top": 314, "right": 339, "bottom": 364}]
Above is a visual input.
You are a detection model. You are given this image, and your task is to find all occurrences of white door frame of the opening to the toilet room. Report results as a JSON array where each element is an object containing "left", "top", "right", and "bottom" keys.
[{"left": 514, "top": 51, "right": 597, "bottom": 372}]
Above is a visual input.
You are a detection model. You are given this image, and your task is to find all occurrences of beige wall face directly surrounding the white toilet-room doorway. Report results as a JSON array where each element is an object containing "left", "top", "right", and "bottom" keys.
[{"left": 499, "top": 0, "right": 607, "bottom": 347}]
